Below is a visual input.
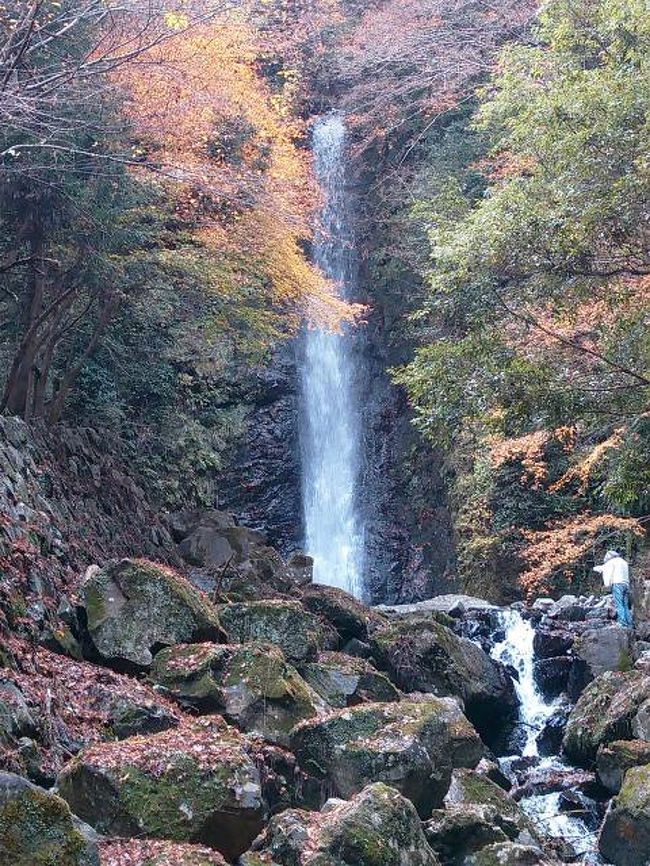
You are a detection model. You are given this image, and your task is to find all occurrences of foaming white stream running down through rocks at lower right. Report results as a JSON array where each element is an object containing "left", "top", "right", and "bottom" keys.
[{"left": 491, "top": 609, "right": 604, "bottom": 866}]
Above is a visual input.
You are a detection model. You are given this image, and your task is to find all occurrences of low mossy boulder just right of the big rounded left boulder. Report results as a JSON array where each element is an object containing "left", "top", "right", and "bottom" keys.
[{"left": 219, "top": 599, "right": 337, "bottom": 662}]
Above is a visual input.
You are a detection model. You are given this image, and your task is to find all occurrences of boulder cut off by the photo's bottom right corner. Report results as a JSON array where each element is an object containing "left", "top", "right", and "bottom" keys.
[{"left": 598, "top": 764, "right": 650, "bottom": 866}]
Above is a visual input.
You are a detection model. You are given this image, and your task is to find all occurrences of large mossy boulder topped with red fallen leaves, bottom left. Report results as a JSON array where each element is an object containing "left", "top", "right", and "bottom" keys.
[{"left": 58, "top": 717, "right": 267, "bottom": 859}]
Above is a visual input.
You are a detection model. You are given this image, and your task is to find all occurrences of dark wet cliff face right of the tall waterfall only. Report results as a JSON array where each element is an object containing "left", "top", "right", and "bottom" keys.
[{"left": 354, "top": 308, "right": 456, "bottom": 603}]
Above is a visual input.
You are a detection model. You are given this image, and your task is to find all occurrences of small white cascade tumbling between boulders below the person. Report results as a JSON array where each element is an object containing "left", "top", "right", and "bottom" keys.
[{"left": 491, "top": 609, "right": 603, "bottom": 866}]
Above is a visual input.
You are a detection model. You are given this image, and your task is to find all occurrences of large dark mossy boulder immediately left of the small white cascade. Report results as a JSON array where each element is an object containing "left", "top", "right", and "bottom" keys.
[{"left": 370, "top": 616, "right": 517, "bottom": 735}]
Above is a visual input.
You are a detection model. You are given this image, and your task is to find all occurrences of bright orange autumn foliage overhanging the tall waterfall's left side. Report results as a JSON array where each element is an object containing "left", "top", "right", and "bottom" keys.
[{"left": 118, "top": 13, "right": 357, "bottom": 327}]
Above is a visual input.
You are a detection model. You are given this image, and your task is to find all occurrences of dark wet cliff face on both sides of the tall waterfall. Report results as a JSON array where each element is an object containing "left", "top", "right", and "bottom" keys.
[{"left": 218, "top": 308, "right": 455, "bottom": 603}]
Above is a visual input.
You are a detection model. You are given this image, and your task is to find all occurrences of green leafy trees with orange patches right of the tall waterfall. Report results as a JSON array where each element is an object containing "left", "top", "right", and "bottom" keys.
[{"left": 393, "top": 0, "right": 650, "bottom": 594}]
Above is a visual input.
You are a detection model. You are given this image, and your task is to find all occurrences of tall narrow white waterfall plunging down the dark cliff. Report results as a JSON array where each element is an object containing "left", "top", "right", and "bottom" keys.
[{"left": 301, "top": 113, "right": 363, "bottom": 596}]
